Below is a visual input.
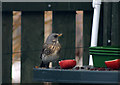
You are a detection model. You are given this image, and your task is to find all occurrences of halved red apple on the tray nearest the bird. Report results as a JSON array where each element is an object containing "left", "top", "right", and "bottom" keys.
[{"left": 59, "top": 60, "right": 76, "bottom": 69}]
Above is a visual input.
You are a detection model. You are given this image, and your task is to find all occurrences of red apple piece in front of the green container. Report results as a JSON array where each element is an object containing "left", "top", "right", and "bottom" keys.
[{"left": 105, "top": 59, "right": 120, "bottom": 69}]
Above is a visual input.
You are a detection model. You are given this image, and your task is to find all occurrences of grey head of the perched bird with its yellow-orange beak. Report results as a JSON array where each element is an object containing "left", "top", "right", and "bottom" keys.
[{"left": 46, "top": 33, "right": 62, "bottom": 43}]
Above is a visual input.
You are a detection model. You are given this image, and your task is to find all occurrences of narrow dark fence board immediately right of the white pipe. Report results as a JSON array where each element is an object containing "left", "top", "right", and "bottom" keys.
[{"left": 103, "top": 2, "right": 112, "bottom": 46}]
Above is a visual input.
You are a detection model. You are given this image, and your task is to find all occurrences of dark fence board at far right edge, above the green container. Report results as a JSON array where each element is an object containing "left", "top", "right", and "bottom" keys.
[{"left": 111, "top": 2, "right": 120, "bottom": 46}]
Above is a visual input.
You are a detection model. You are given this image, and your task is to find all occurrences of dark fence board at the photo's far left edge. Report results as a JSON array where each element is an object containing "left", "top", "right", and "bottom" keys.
[{"left": 2, "top": 11, "right": 12, "bottom": 83}]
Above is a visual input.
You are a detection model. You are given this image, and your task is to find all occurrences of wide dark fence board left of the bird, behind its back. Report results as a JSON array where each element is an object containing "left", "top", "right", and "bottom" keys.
[{"left": 21, "top": 11, "right": 44, "bottom": 83}]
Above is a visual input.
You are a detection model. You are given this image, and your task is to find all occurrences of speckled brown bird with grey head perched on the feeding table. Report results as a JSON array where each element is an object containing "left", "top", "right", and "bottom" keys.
[{"left": 40, "top": 33, "right": 62, "bottom": 68}]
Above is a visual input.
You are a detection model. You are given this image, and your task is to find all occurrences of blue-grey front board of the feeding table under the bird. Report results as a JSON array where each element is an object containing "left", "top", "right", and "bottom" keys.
[{"left": 33, "top": 68, "right": 119, "bottom": 85}]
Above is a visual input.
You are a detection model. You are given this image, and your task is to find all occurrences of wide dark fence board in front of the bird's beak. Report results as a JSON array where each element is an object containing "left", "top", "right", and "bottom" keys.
[{"left": 53, "top": 11, "right": 76, "bottom": 59}]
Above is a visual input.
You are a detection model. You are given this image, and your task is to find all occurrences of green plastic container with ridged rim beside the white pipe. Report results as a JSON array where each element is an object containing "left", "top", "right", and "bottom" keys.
[{"left": 89, "top": 46, "right": 120, "bottom": 67}]
